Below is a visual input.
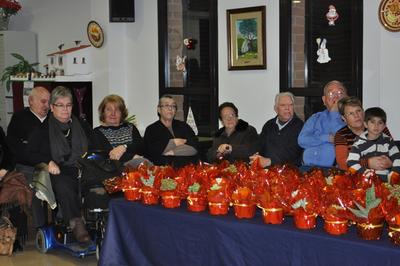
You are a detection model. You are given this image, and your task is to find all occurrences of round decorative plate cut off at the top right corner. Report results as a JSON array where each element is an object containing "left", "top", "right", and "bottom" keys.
[{"left": 378, "top": 0, "right": 400, "bottom": 31}]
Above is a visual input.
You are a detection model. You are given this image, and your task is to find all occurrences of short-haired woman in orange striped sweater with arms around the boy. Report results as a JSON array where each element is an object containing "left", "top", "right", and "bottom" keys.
[{"left": 335, "top": 96, "right": 392, "bottom": 170}]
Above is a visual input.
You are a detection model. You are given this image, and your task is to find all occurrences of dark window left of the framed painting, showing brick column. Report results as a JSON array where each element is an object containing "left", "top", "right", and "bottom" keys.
[{"left": 158, "top": 0, "right": 218, "bottom": 136}]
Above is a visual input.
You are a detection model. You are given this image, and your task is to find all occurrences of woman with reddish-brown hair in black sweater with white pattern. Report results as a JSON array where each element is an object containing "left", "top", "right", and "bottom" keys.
[{"left": 94, "top": 95, "right": 144, "bottom": 166}]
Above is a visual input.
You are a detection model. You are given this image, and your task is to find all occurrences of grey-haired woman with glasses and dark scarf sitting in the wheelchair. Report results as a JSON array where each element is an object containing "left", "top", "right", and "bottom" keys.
[{"left": 27, "top": 86, "right": 93, "bottom": 243}]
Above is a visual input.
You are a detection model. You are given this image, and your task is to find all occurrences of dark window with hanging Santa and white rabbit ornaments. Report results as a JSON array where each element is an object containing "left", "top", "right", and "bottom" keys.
[{"left": 280, "top": 0, "right": 363, "bottom": 119}]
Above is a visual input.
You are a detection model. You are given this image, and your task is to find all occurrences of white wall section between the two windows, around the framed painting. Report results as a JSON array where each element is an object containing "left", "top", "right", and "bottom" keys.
[{"left": 218, "top": 0, "right": 279, "bottom": 132}]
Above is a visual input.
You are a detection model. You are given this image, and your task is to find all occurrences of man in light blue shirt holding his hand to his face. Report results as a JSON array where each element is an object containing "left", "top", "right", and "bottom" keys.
[{"left": 298, "top": 80, "right": 347, "bottom": 167}]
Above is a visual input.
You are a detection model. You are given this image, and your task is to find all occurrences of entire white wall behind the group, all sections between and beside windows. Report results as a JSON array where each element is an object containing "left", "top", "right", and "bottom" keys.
[{"left": 10, "top": 0, "right": 400, "bottom": 139}]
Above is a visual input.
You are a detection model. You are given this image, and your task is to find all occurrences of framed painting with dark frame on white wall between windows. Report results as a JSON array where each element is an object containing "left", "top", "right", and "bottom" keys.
[{"left": 226, "top": 6, "right": 267, "bottom": 70}]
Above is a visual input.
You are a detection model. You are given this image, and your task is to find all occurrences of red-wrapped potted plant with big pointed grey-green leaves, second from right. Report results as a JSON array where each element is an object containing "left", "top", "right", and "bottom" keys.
[{"left": 348, "top": 185, "right": 383, "bottom": 240}]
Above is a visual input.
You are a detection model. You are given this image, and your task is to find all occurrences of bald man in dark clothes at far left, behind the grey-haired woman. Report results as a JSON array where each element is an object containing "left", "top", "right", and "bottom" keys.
[{"left": 7, "top": 86, "right": 50, "bottom": 227}]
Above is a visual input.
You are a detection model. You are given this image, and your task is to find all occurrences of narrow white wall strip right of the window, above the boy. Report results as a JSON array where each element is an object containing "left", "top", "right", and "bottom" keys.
[{"left": 363, "top": 0, "right": 400, "bottom": 140}]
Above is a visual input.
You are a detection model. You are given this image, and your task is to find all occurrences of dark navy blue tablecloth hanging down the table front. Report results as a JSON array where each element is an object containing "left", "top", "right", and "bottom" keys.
[{"left": 99, "top": 199, "right": 400, "bottom": 266}]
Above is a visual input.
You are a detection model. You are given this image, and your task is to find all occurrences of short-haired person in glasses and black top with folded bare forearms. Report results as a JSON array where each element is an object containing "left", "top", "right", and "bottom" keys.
[{"left": 144, "top": 95, "right": 198, "bottom": 167}]
